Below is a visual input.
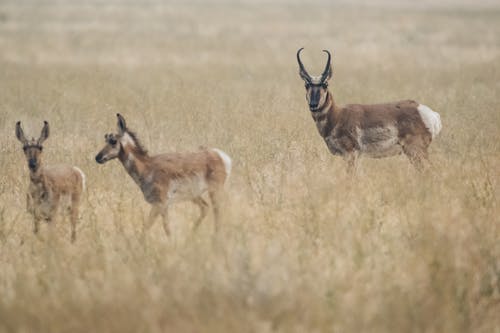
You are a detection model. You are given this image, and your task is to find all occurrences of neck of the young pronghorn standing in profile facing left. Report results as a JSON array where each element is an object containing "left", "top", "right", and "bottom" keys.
[{"left": 118, "top": 133, "right": 149, "bottom": 184}]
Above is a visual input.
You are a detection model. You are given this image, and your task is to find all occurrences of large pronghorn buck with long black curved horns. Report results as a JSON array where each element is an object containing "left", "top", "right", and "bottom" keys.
[{"left": 297, "top": 48, "right": 442, "bottom": 171}]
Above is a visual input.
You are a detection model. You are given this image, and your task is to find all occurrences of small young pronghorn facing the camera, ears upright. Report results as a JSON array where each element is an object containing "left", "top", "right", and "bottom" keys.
[{"left": 16, "top": 121, "right": 85, "bottom": 242}]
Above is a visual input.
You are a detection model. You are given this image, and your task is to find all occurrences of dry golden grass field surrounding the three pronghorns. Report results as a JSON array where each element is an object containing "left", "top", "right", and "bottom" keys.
[{"left": 0, "top": 0, "right": 500, "bottom": 332}]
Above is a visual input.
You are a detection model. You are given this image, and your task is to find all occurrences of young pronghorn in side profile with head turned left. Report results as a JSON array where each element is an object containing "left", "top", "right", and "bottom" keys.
[{"left": 95, "top": 114, "right": 232, "bottom": 236}]
